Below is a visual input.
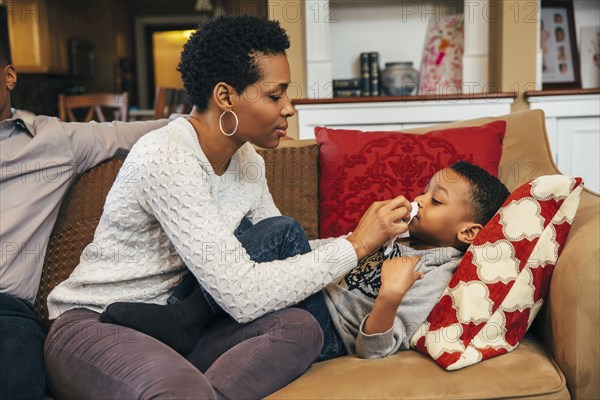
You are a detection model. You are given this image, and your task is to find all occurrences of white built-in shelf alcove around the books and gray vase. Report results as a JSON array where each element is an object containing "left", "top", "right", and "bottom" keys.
[{"left": 304, "top": 0, "right": 491, "bottom": 102}]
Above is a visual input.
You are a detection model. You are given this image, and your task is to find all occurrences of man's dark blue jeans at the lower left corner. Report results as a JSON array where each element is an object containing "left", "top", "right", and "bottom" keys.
[{"left": 0, "top": 293, "right": 46, "bottom": 399}]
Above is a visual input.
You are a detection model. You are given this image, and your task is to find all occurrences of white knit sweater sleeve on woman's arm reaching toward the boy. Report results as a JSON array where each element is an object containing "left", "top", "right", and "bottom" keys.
[{"left": 139, "top": 143, "right": 356, "bottom": 322}]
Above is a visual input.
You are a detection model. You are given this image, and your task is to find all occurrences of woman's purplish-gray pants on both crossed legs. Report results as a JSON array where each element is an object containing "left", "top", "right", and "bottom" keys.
[{"left": 45, "top": 308, "right": 323, "bottom": 399}]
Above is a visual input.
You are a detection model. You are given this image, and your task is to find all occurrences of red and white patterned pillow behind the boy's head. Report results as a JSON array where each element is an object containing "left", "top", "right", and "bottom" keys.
[{"left": 411, "top": 175, "right": 582, "bottom": 370}]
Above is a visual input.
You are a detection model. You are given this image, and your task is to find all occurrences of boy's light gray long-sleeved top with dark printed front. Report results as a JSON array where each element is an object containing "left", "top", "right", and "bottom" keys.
[{"left": 325, "top": 243, "right": 463, "bottom": 358}]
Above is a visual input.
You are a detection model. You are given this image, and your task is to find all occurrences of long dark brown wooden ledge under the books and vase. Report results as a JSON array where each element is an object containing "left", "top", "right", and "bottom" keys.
[{"left": 292, "top": 92, "right": 517, "bottom": 105}]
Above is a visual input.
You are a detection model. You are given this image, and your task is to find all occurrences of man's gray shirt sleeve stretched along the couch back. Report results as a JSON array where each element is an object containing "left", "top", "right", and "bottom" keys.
[{"left": 60, "top": 119, "right": 169, "bottom": 174}]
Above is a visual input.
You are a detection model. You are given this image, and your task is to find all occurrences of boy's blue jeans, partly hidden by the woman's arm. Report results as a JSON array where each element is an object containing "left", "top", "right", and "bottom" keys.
[{"left": 168, "top": 216, "right": 346, "bottom": 362}]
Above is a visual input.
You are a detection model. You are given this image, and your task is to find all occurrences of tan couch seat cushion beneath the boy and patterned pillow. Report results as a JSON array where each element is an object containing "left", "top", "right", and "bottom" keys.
[{"left": 267, "top": 338, "right": 569, "bottom": 400}]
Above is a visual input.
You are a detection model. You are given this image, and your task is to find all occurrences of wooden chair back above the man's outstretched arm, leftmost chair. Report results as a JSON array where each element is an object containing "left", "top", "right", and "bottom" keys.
[{"left": 58, "top": 92, "right": 129, "bottom": 122}]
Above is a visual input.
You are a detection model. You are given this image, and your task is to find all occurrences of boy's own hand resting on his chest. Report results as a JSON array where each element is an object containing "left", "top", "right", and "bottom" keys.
[{"left": 378, "top": 255, "right": 423, "bottom": 304}]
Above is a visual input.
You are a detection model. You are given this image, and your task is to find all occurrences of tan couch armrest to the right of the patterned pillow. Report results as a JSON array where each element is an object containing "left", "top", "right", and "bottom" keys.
[{"left": 534, "top": 190, "right": 600, "bottom": 399}]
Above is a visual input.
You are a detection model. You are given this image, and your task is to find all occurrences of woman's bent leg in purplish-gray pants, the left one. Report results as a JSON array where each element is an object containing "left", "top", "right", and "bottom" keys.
[{"left": 45, "top": 310, "right": 215, "bottom": 399}]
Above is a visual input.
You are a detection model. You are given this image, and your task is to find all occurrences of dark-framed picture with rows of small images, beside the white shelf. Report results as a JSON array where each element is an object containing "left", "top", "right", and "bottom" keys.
[{"left": 540, "top": 0, "right": 581, "bottom": 89}]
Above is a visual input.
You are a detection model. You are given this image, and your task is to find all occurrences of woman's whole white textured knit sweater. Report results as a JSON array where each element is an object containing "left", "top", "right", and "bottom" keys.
[{"left": 48, "top": 118, "right": 357, "bottom": 322}]
